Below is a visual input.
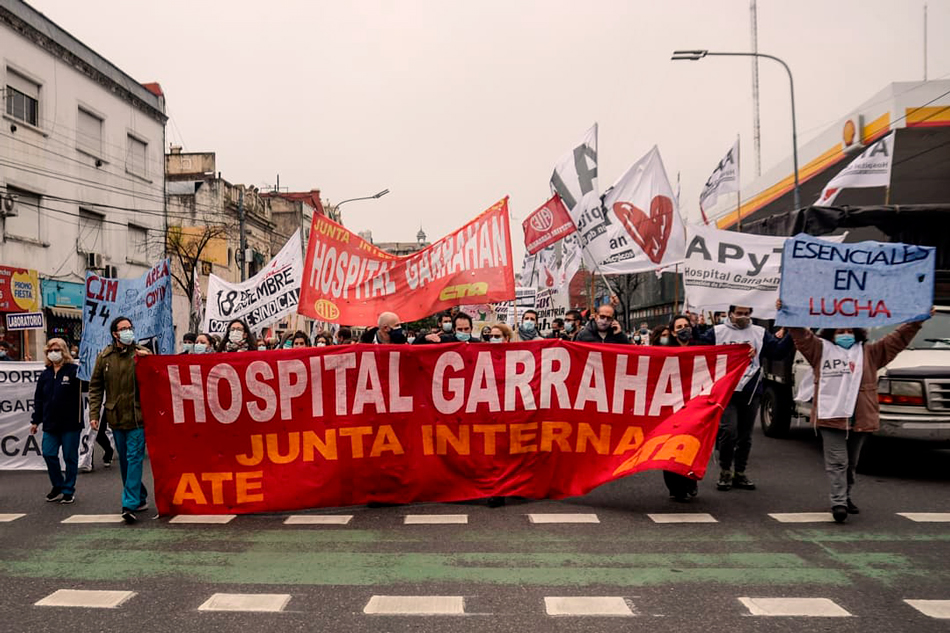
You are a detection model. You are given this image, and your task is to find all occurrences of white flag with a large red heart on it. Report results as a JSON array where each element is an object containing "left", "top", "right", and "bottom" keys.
[{"left": 600, "top": 146, "right": 686, "bottom": 274}]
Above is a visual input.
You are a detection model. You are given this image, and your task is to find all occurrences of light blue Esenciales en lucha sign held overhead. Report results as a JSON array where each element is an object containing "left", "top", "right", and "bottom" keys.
[{"left": 776, "top": 234, "right": 936, "bottom": 328}]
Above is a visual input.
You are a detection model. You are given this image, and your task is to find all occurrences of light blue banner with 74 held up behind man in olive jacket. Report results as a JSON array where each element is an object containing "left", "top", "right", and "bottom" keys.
[{"left": 79, "top": 259, "right": 175, "bottom": 380}]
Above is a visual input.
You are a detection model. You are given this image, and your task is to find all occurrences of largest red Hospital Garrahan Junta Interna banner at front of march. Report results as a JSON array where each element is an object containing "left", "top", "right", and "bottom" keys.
[{"left": 137, "top": 340, "right": 749, "bottom": 514}]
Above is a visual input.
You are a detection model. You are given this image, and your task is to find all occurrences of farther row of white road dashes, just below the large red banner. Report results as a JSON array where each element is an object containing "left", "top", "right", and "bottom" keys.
[{"left": 0, "top": 512, "right": 950, "bottom": 527}]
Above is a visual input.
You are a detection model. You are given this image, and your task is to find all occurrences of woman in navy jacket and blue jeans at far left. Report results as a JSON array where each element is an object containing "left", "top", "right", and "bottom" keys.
[{"left": 30, "top": 338, "right": 83, "bottom": 503}]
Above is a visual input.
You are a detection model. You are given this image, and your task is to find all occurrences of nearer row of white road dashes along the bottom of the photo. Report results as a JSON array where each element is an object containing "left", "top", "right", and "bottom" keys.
[{"left": 27, "top": 589, "right": 950, "bottom": 620}]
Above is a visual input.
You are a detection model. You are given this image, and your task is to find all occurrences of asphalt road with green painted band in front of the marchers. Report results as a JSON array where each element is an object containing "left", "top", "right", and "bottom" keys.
[{"left": 0, "top": 420, "right": 950, "bottom": 633}]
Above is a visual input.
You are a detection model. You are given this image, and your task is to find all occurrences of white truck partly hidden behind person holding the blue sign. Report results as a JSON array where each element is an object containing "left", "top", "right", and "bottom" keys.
[{"left": 760, "top": 306, "right": 950, "bottom": 445}]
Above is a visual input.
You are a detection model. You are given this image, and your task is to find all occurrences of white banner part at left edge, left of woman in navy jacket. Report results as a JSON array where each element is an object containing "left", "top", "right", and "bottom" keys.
[{"left": 0, "top": 362, "right": 46, "bottom": 470}]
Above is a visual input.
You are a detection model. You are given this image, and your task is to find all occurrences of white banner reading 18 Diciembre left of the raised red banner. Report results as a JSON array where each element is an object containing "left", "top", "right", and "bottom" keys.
[{"left": 201, "top": 229, "right": 303, "bottom": 334}]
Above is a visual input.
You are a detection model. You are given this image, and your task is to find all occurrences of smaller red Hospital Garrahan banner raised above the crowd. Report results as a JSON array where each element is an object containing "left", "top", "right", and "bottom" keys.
[{"left": 297, "top": 198, "right": 515, "bottom": 325}]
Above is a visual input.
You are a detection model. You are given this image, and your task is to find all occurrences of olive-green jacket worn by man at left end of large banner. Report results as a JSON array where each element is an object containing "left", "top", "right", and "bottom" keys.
[{"left": 89, "top": 345, "right": 148, "bottom": 431}]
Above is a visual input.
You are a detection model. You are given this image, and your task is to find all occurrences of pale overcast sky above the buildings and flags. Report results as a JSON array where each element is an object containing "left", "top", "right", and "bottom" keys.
[{"left": 24, "top": 0, "right": 950, "bottom": 263}]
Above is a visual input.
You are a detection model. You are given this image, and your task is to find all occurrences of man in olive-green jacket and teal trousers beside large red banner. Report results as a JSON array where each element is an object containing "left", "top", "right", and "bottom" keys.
[{"left": 89, "top": 317, "right": 151, "bottom": 523}]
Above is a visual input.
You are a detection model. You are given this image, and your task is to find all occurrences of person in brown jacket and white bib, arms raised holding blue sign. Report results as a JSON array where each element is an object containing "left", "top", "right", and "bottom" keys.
[{"left": 776, "top": 301, "right": 934, "bottom": 523}]
